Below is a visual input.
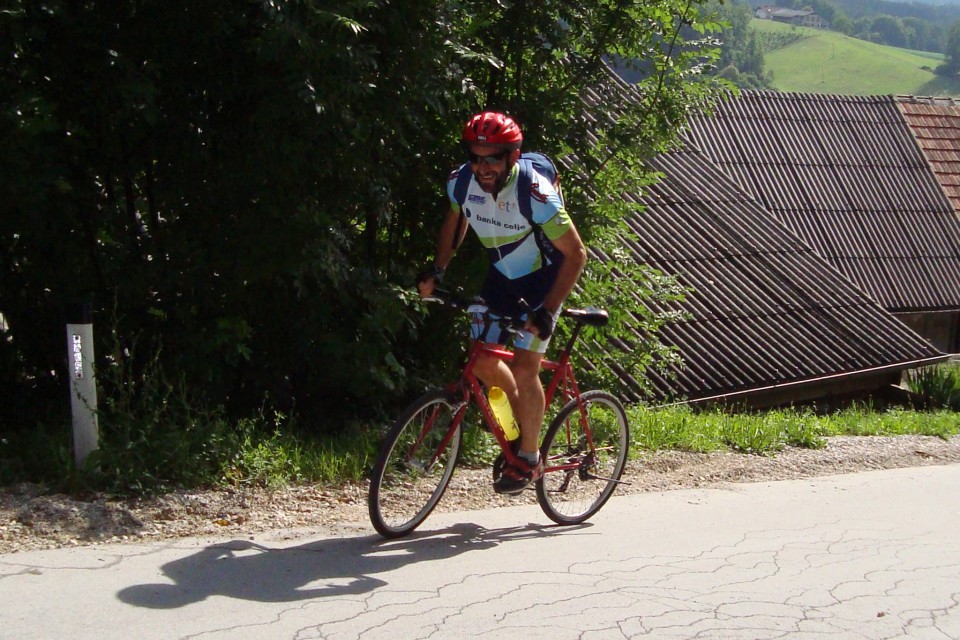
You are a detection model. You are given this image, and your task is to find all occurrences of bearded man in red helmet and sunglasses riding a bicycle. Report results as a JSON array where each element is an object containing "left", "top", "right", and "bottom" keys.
[{"left": 417, "top": 111, "right": 587, "bottom": 495}]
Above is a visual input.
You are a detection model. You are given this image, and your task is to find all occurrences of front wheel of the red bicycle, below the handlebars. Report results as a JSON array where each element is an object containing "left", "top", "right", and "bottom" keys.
[{"left": 367, "top": 389, "right": 463, "bottom": 538}]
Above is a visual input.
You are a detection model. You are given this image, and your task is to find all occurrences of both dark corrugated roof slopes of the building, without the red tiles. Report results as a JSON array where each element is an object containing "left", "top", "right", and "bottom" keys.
[{"left": 586, "top": 77, "right": 960, "bottom": 406}]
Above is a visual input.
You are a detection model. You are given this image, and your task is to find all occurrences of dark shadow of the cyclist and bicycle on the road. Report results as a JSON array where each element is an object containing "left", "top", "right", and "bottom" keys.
[{"left": 117, "top": 523, "right": 590, "bottom": 609}]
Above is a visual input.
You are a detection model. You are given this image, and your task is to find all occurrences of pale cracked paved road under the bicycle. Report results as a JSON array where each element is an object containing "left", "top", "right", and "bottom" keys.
[{"left": 0, "top": 465, "right": 960, "bottom": 640}]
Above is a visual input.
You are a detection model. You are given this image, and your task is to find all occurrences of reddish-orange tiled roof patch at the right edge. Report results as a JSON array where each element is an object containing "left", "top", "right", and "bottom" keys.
[{"left": 896, "top": 96, "right": 960, "bottom": 211}]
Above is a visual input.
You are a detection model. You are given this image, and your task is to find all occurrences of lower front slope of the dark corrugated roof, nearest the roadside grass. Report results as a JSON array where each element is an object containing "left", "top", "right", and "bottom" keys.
[{"left": 623, "top": 150, "right": 941, "bottom": 400}]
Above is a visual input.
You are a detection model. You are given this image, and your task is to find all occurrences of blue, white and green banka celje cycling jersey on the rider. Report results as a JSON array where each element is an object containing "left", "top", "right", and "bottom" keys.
[{"left": 447, "top": 165, "right": 571, "bottom": 280}]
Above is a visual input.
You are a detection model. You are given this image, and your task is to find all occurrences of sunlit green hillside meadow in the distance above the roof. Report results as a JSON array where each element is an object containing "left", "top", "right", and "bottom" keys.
[{"left": 750, "top": 19, "right": 960, "bottom": 96}]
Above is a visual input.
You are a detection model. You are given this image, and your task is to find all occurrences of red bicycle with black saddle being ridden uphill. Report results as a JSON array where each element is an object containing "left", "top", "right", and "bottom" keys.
[{"left": 368, "top": 291, "right": 630, "bottom": 538}]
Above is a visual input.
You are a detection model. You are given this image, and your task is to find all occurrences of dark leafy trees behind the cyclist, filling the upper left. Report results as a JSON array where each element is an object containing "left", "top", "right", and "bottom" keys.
[{"left": 0, "top": 0, "right": 716, "bottom": 450}]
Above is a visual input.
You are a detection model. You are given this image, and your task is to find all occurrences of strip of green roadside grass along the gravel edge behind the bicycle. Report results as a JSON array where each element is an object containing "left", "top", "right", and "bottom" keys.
[{"left": 0, "top": 365, "right": 960, "bottom": 495}]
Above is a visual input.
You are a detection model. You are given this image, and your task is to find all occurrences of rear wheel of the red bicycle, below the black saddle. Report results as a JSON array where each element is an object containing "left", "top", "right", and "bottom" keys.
[{"left": 537, "top": 391, "right": 630, "bottom": 524}]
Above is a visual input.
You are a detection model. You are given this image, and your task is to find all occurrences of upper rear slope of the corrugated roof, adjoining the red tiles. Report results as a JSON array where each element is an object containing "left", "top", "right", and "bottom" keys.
[{"left": 687, "top": 91, "right": 960, "bottom": 312}]
